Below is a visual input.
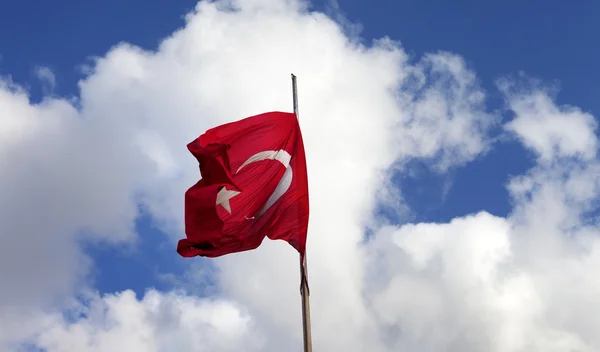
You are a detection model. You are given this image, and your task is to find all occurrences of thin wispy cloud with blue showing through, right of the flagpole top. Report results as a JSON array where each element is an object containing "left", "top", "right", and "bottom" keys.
[{"left": 395, "top": 52, "right": 496, "bottom": 171}]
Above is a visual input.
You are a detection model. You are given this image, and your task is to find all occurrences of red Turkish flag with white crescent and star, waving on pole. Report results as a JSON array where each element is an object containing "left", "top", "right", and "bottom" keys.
[{"left": 177, "top": 112, "right": 309, "bottom": 257}]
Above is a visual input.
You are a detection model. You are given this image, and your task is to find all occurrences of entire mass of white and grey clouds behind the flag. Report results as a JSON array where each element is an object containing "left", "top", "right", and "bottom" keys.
[{"left": 0, "top": 0, "right": 600, "bottom": 352}]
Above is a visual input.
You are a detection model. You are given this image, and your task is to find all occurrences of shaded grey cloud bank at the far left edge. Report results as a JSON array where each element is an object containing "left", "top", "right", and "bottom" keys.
[{"left": 0, "top": 77, "right": 144, "bottom": 306}]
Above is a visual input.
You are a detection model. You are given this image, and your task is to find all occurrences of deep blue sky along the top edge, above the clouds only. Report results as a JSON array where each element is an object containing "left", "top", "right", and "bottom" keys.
[{"left": 0, "top": 0, "right": 600, "bottom": 111}]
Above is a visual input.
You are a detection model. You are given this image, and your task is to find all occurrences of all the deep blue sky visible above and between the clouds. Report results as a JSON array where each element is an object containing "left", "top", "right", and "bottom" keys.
[{"left": 0, "top": 0, "right": 600, "bottom": 350}]
